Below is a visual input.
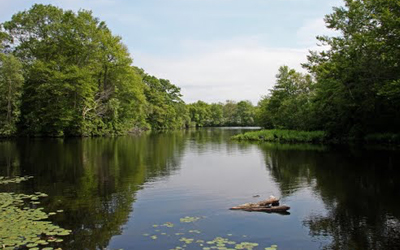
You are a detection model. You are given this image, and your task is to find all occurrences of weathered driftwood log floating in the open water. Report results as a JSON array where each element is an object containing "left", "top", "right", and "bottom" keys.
[{"left": 230, "top": 196, "right": 290, "bottom": 213}]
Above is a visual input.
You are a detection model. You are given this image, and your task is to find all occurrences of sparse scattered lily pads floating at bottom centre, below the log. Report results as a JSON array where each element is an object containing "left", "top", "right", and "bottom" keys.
[{"left": 143, "top": 216, "right": 278, "bottom": 250}]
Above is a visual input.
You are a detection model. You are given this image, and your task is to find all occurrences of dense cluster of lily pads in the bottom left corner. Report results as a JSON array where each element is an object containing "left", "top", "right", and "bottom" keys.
[{"left": 0, "top": 177, "right": 71, "bottom": 250}]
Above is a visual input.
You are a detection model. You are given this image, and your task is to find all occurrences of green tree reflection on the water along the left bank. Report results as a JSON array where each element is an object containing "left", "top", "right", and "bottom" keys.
[{"left": 0, "top": 133, "right": 184, "bottom": 249}]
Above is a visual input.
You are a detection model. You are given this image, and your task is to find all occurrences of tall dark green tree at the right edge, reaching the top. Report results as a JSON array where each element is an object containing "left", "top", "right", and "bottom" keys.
[{"left": 305, "top": 0, "right": 400, "bottom": 137}]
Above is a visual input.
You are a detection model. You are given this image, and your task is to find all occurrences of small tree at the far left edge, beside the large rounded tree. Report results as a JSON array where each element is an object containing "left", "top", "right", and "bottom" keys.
[{"left": 0, "top": 53, "right": 24, "bottom": 136}]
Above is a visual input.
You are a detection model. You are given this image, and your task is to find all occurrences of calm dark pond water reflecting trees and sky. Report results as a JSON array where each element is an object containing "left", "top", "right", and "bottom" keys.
[{"left": 0, "top": 129, "right": 400, "bottom": 250}]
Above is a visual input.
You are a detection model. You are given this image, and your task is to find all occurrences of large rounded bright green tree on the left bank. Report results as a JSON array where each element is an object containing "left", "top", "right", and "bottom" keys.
[{"left": 3, "top": 4, "right": 145, "bottom": 136}]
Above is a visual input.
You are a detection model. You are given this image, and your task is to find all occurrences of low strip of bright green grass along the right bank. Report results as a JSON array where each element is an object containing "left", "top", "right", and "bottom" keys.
[{"left": 232, "top": 129, "right": 327, "bottom": 143}]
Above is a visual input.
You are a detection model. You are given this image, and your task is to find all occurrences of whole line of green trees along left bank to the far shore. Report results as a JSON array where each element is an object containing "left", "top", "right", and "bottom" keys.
[{"left": 0, "top": 4, "right": 252, "bottom": 136}]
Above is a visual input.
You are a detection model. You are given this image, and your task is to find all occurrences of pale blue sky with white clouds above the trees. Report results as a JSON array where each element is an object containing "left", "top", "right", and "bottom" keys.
[{"left": 0, "top": 0, "right": 343, "bottom": 104}]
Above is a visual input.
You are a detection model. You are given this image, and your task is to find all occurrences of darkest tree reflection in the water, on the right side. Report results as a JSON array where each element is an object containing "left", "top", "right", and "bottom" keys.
[{"left": 261, "top": 144, "right": 400, "bottom": 249}]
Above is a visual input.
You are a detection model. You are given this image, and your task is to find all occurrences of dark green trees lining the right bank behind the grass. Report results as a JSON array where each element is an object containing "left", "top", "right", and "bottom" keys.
[{"left": 257, "top": 0, "right": 400, "bottom": 138}]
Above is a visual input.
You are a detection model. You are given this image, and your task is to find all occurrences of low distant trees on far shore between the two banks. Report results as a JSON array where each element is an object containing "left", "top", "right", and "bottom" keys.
[{"left": 188, "top": 101, "right": 256, "bottom": 127}]
